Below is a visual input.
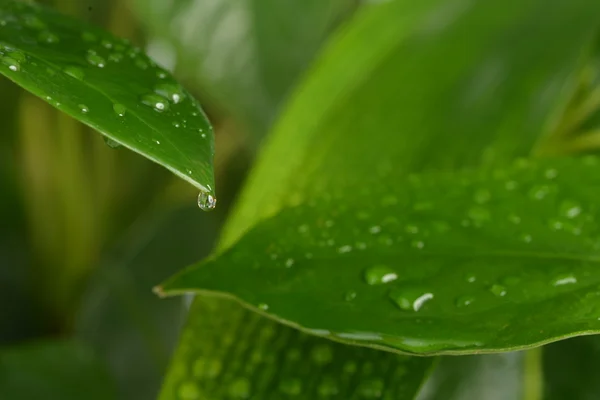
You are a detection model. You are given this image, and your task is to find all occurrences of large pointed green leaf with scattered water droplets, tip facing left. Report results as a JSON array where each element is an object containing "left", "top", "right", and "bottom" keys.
[{"left": 162, "top": 157, "right": 600, "bottom": 354}]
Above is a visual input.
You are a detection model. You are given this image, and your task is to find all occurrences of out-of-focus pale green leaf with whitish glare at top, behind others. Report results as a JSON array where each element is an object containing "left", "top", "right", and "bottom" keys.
[{"left": 133, "top": 0, "right": 353, "bottom": 136}]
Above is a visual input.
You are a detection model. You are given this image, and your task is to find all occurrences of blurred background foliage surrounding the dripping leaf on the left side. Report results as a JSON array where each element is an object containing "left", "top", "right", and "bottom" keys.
[{"left": 0, "top": 0, "right": 360, "bottom": 399}]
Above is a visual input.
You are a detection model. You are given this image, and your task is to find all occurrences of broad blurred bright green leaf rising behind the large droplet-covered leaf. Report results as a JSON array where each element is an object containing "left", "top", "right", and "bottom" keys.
[{"left": 223, "top": 0, "right": 600, "bottom": 246}]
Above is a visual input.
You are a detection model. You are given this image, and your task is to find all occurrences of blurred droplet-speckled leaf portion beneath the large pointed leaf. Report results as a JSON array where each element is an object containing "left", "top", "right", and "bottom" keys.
[{"left": 160, "top": 298, "right": 433, "bottom": 400}]
